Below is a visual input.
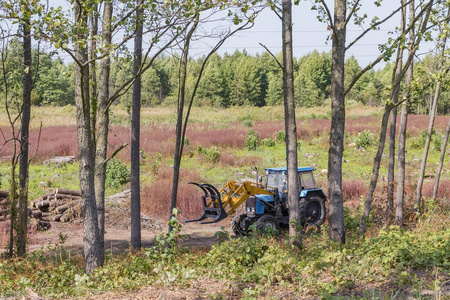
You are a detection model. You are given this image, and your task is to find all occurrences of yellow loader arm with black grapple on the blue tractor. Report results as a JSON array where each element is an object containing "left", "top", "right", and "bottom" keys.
[{"left": 185, "top": 180, "right": 274, "bottom": 224}]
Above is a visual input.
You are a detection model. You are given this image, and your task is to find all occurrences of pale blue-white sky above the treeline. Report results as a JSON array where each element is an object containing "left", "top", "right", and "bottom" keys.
[{"left": 50, "top": 0, "right": 440, "bottom": 68}]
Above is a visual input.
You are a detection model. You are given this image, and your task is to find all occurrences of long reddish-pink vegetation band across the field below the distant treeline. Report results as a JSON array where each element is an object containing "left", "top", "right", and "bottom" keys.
[{"left": 0, "top": 115, "right": 448, "bottom": 164}]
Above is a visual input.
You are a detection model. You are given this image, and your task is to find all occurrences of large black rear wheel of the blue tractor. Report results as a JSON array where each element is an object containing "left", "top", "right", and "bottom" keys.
[{"left": 299, "top": 195, "right": 327, "bottom": 228}]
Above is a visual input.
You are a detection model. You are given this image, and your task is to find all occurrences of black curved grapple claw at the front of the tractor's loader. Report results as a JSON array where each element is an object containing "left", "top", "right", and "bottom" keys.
[{"left": 184, "top": 182, "right": 228, "bottom": 224}]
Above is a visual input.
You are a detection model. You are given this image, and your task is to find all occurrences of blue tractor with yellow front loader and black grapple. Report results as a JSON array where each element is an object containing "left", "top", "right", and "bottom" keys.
[{"left": 186, "top": 167, "right": 326, "bottom": 236}]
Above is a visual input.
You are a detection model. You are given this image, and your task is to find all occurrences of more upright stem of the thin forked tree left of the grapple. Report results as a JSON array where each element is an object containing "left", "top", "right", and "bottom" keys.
[{"left": 169, "top": 21, "right": 198, "bottom": 232}]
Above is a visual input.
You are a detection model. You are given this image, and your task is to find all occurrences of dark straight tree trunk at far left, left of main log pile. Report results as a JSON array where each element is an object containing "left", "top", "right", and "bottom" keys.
[{"left": 17, "top": 12, "right": 33, "bottom": 256}]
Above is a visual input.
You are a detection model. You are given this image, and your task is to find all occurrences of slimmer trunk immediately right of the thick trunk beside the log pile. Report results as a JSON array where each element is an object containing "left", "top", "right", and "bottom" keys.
[{"left": 95, "top": 2, "right": 113, "bottom": 265}]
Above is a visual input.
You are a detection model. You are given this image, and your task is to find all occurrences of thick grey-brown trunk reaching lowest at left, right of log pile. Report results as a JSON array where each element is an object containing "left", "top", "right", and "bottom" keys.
[{"left": 75, "top": 2, "right": 101, "bottom": 274}]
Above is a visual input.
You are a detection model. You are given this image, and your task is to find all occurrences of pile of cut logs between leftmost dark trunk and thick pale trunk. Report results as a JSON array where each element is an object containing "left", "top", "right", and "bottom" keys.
[{"left": 28, "top": 189, "right": 82, "bottom": 222}]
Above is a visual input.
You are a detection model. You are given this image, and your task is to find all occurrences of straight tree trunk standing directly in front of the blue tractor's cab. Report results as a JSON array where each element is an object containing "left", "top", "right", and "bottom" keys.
[{"left": 282, "top": 0, "right": 302, "bottom": 246}]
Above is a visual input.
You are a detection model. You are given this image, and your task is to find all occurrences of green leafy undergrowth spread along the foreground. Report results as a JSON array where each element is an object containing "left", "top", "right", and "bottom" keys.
[{"left": 0, "top": 218, "right": 450, "bottom": 298}]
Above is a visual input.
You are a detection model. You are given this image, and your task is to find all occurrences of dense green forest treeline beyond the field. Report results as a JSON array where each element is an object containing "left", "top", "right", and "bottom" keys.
[{"left": 0, "top": 41, "right": 450, "bottom": 114}]
